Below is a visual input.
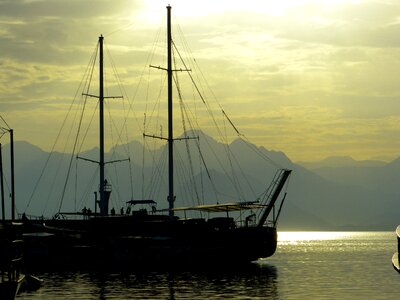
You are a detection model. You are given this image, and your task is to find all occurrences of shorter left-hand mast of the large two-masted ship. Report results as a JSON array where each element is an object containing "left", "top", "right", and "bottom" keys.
[{"left": 99, "top": 35, "right": 108, "bottom": 216}]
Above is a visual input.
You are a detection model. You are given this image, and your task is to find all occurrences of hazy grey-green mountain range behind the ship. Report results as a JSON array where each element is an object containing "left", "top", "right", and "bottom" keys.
[{"left": 3, "top": 137, "right": 400, "bottom": 230}]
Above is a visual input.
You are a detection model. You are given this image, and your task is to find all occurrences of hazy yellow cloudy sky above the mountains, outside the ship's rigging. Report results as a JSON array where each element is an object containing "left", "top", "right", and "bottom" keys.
[{"left": 0, "top": 0, "right": 400, "bottom": 161}]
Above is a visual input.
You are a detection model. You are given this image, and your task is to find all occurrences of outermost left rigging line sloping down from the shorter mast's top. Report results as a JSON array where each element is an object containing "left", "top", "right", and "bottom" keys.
[{"left": 24, "top": 45, "right": 98, "bottom": 213}]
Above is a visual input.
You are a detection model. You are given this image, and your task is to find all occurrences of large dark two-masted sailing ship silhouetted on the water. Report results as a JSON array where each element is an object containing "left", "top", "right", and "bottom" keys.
[{"left": 24, "top": 6, "right": 291, "bottom": 267}]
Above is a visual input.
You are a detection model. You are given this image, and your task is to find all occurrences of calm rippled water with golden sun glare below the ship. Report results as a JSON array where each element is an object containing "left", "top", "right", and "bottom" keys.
[{"left": 17, "top": 232, "right": 400, "bottom": 300}]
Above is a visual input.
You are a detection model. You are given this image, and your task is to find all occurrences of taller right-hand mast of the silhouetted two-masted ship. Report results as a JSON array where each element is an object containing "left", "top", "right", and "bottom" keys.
[{"left": 167, "top": 5, "right": 175, "bottom": 219}]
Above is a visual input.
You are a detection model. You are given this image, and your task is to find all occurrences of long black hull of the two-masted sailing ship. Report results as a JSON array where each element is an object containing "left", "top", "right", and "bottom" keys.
[{"left": 25, "top": 217, "right": 277, "bottom": 269}]
